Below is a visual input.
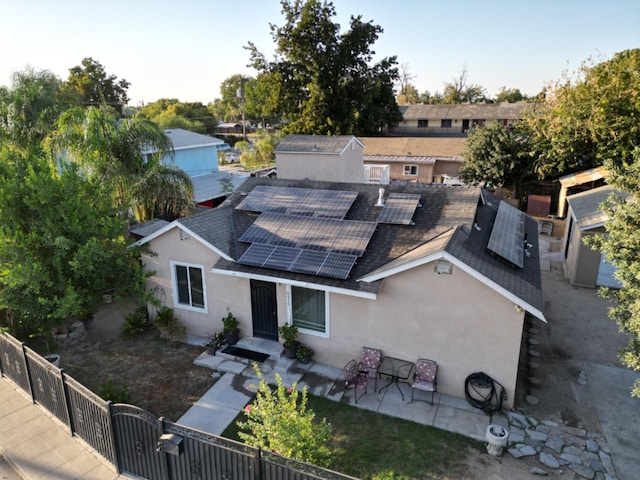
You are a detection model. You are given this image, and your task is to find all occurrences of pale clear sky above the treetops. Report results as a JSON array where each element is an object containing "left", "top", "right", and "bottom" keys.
[{"left": 0, "top": 0, "right": 640, "bottom": 106}]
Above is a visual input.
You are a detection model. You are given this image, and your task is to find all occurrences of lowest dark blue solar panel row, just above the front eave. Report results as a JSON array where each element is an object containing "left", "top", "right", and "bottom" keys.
[{"left": 238, "top": 243, "right": 358, "bottom": 280}]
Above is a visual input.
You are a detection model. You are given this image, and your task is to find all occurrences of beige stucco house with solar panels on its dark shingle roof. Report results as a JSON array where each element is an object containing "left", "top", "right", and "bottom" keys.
[{"left": 139, "top": 136, "right": 544, "bottom": 407}]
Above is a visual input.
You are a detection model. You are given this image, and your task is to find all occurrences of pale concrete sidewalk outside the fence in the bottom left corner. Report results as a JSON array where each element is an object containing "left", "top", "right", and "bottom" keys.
[{"left": 0, "top": 378, "right": 128, "bottom": 480}]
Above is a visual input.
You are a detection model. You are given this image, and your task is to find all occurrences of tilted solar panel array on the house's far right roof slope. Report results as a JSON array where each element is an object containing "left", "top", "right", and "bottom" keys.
[{"left": 487, "top": 201, "right": 524, "bottom": 268}]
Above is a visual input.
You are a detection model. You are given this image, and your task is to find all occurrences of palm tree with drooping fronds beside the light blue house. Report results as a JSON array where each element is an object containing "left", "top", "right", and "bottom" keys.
[{"left": 48, "top": 106, "right": 193, "bottom": 220}]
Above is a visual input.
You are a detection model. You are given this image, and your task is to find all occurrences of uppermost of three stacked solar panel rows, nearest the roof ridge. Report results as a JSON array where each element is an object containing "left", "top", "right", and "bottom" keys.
[{"left": 236, "top": 185, "right": 358, "bottom": 218}]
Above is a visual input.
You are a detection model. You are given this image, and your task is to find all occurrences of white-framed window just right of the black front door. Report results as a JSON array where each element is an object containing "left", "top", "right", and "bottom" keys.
[{"left": 290, "top": 286, "right": 329, "bottom": 335}]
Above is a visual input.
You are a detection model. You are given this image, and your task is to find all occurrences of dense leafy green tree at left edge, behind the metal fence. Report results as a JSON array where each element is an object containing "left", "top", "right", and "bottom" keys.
[{"left": 0, "top": 145, "right": 144, "bottom": 339}]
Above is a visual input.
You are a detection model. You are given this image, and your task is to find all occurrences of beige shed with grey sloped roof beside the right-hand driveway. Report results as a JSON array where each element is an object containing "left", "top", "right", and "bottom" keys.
[{"left": 564, "top": 185, "right": 626, "bottom": 288}]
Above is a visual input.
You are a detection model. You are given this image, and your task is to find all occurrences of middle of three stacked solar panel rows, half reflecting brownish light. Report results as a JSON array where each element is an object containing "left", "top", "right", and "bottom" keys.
[{"left": 240, "top": 212, "right": 377, "bottom": 257}]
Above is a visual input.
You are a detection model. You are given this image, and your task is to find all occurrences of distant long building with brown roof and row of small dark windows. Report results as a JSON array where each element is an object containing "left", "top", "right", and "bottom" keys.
[{"left": 396, "top": 102, "right": 533, "bottom": 136}]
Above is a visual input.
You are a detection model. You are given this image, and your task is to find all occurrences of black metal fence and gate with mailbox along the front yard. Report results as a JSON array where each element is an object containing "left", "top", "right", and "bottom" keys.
[{"left": 0, "top": 333, "right": 354, "bottom": 480}]
